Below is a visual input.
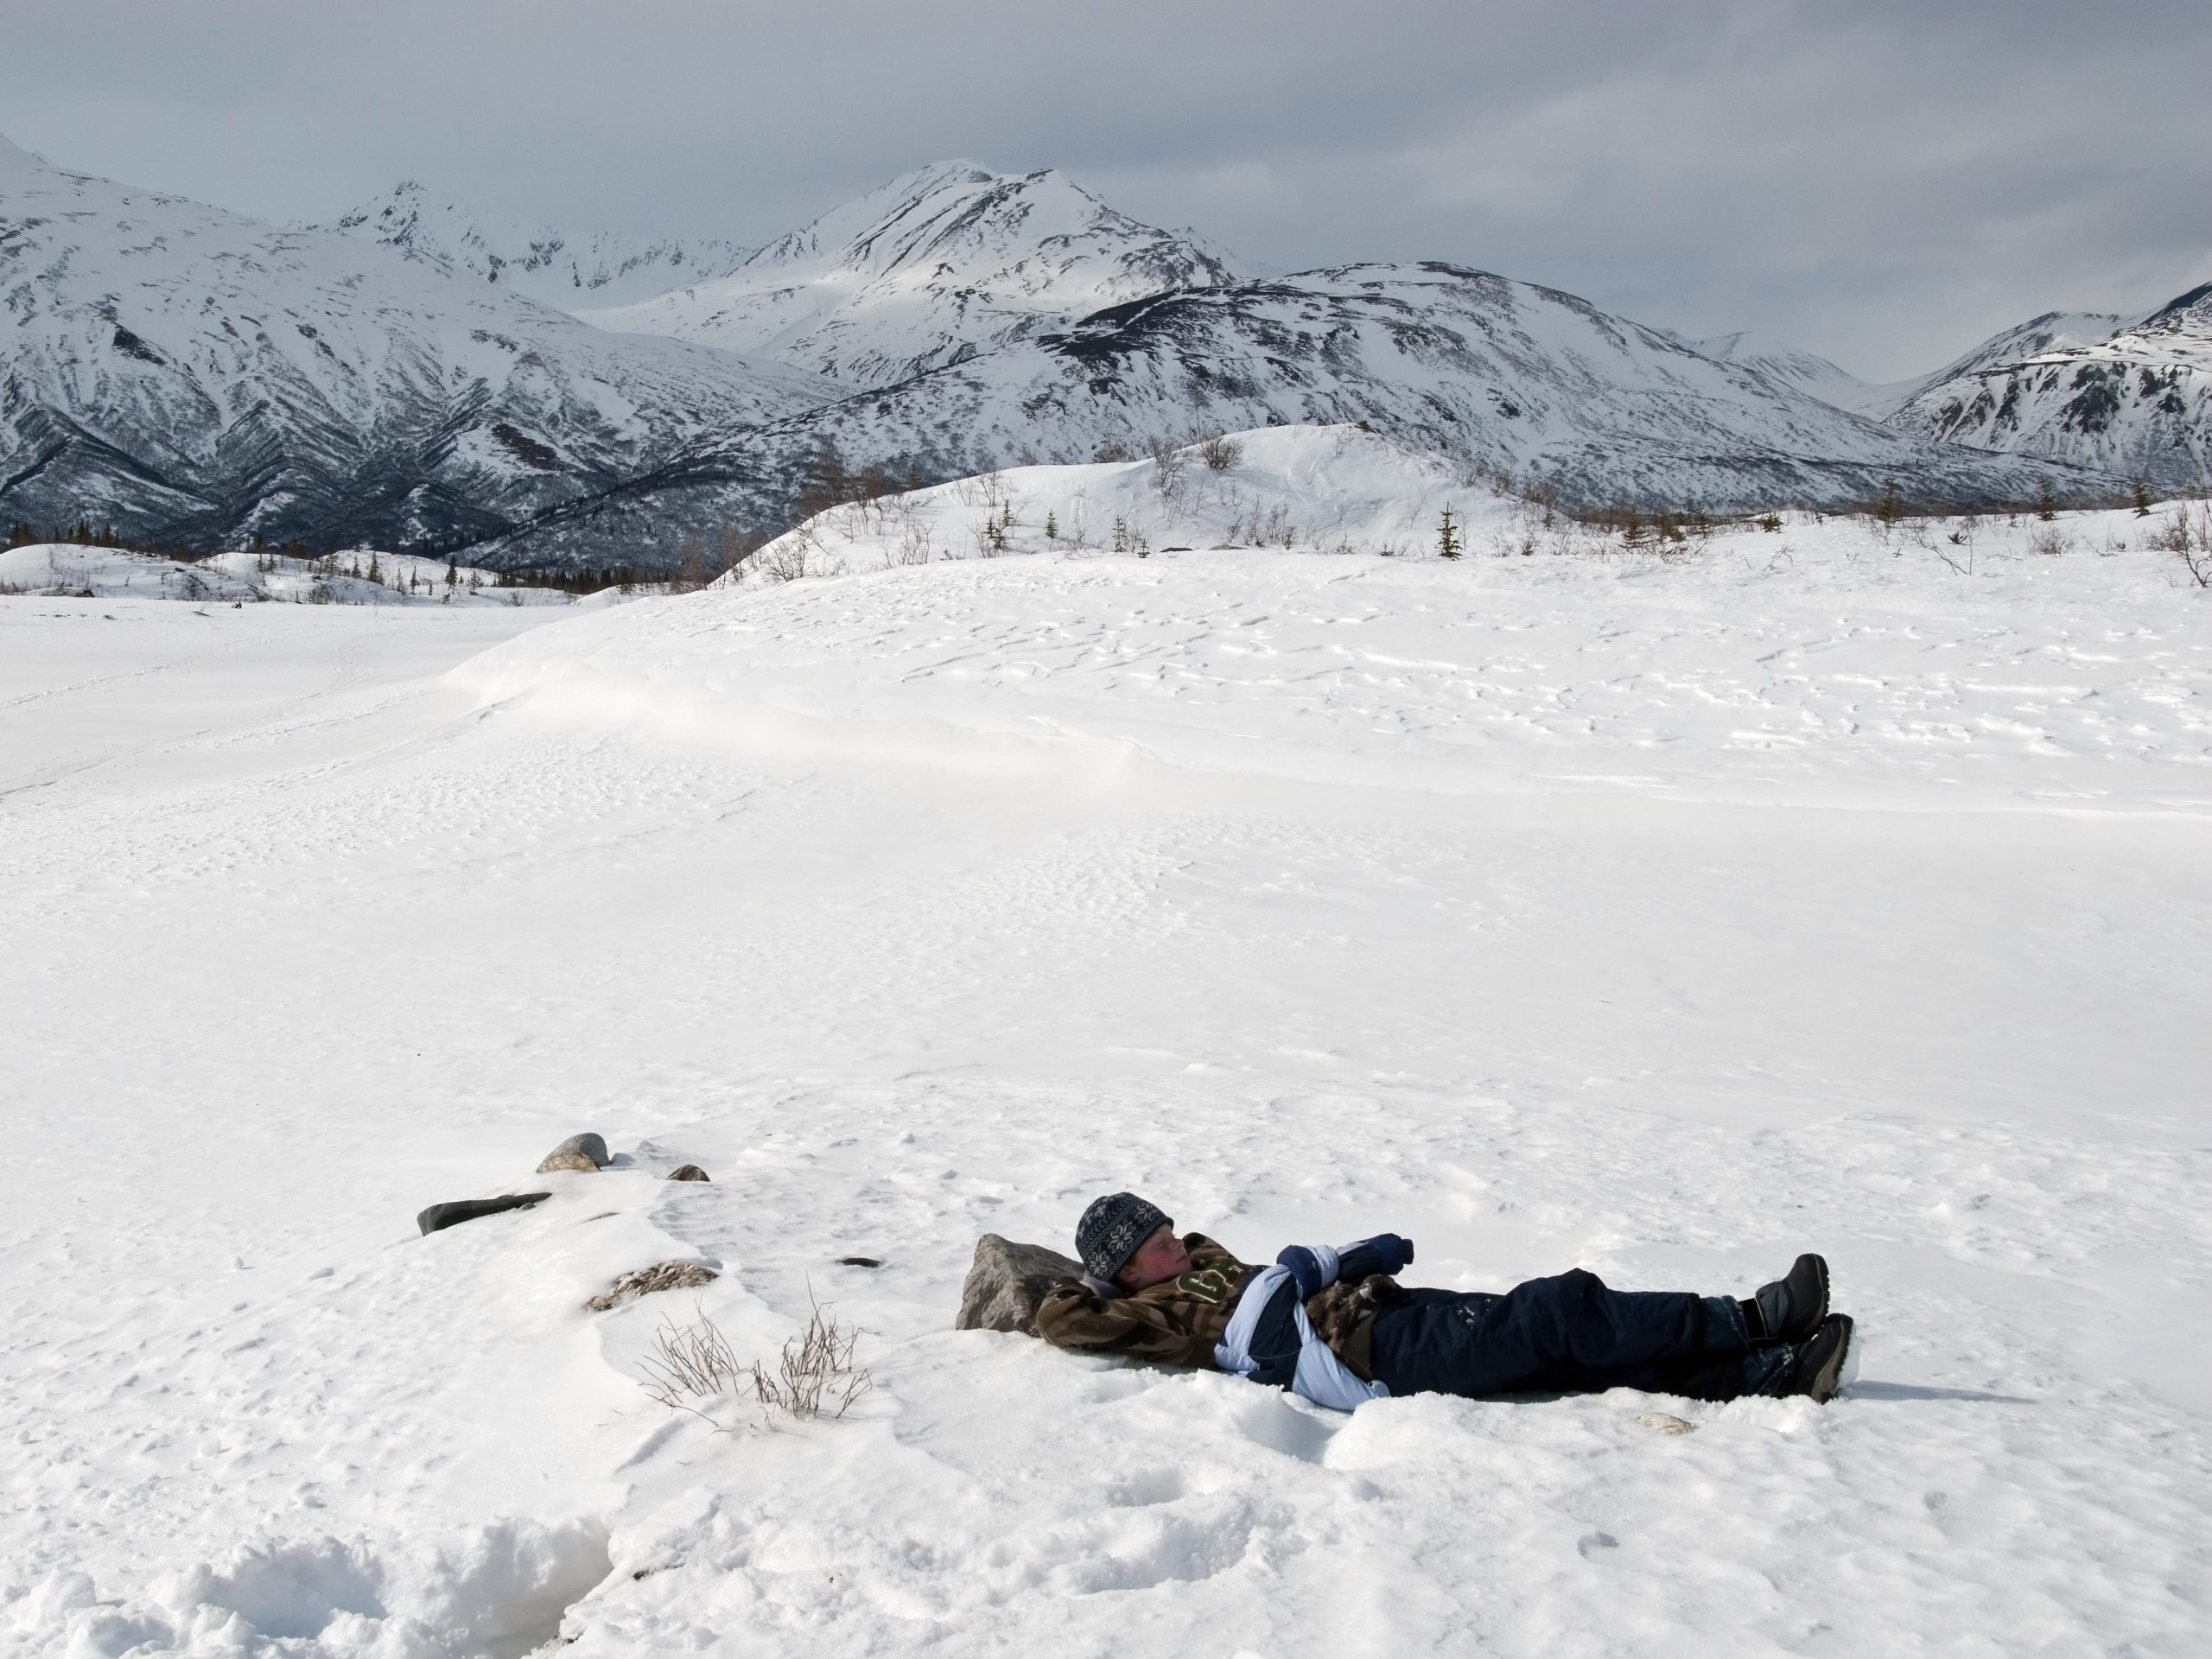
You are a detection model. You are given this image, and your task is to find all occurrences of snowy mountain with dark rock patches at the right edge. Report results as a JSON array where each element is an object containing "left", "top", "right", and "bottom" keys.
[{"left": 1889, "top": 285, "right": 2212, "bottom": 491}]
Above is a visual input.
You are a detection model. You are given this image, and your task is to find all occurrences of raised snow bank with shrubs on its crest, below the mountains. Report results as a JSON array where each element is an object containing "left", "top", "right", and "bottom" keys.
[{"left": 465, "top": 477, "right": 2212, "bottom": 812}]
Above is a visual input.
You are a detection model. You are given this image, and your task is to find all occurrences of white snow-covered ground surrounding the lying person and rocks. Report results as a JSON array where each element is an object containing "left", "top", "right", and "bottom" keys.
[{"left": 0, "top": 526, "right": 2212, "bottom": 1659}]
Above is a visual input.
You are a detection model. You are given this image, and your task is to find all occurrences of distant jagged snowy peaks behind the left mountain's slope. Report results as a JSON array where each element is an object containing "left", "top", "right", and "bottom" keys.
[{"left": 323, "top": 179, "right": 752, "bottom": 311}]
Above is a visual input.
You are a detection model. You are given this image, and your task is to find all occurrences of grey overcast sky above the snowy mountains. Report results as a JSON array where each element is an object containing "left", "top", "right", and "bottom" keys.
[{"left": 0, "top": 0, "right": 2212, "bottom": 380}]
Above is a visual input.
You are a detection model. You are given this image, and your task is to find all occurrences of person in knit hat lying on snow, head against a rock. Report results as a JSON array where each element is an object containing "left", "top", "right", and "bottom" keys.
[{"left": 1038, "top": 1192, "right": 1852, "bottom": 1411}]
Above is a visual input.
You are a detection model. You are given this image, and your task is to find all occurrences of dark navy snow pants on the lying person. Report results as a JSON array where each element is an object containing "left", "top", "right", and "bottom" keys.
[{"left": 1374, "top": 1268, "right": 1778, "bottom": 1400}]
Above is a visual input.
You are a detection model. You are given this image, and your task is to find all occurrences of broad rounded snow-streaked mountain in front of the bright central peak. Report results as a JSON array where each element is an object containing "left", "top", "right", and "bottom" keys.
[{"left": 482, "top": 264, "right": 2121, "bottom": 564}]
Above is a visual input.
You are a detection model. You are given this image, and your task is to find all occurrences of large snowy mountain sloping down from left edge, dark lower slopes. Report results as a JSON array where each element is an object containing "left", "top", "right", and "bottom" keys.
[{"left": 0, "top": 139, "right": 827, "bottom": 546}]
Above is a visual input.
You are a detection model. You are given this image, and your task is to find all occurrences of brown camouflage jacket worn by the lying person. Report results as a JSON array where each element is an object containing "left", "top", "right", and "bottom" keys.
[{"left": 1038, "top": 1232, "right": 1398, "bottom": 1382}]
